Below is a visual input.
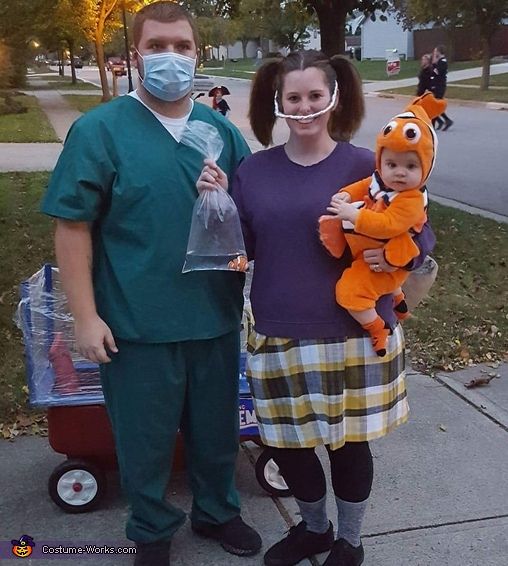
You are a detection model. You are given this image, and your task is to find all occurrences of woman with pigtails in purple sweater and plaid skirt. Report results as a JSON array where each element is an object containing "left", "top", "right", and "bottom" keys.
[{"left": 198, "top": 51, "right": 433, "bottom": 566}]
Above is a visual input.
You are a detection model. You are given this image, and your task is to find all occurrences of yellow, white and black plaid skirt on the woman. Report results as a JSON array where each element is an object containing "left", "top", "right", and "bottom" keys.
[{"left": 247, "top": 325, "right": 409, "bottom": 449}]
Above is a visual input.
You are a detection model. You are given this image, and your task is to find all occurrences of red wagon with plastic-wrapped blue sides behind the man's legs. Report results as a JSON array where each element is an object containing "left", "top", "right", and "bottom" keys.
[{"left": 17, "top": 265, "right": 289, "bottom": 513}]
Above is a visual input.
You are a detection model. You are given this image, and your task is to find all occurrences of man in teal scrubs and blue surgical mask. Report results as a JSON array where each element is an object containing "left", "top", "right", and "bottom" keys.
[{"left": 42, "top": 2, "right": 261, "bottom": 566}]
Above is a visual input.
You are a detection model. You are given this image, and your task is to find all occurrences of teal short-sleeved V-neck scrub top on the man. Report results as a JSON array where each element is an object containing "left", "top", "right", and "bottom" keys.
[{"left": 41, "top": 96, "right": 250, "bottom": 343}]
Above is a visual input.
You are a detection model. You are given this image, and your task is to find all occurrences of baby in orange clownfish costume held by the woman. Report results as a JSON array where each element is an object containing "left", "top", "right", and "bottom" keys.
[{"left": 319, "top": 93, "right": 446, "bottom": 356}]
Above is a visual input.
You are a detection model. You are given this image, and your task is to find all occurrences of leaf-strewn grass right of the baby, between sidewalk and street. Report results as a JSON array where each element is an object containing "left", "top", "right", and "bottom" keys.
[{"left": 405, "top": 202, "right": 508, "bottom": 371}]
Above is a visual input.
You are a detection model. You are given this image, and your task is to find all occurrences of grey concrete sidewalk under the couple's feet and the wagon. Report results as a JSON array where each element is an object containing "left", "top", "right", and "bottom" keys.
[{"left": 0, "top": 364, "right": 508, "bottom": 566}]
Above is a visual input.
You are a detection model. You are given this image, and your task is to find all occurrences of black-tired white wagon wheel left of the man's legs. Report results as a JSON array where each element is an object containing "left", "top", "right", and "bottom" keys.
[{"left": 48, "top": 460, "right": 106, "bottom": 513}]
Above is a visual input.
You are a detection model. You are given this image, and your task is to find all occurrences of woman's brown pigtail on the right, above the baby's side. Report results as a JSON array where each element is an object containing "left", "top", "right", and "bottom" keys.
[{"left": 328, "top": 55, "right": 365, "bottom": 141}]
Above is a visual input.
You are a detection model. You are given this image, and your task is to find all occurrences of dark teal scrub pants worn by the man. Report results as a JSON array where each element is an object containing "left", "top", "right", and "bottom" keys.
[{"left": 101, "top": 331, "right": 240, "bottom": 543}]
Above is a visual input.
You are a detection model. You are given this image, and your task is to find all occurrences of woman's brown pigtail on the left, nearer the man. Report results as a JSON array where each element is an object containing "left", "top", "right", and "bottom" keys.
[{"left": 249, "top": 60, "right": 280, "bottom": 147}]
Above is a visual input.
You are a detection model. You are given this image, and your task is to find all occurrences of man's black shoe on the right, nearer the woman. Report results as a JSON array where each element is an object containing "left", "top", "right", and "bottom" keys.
[{"left": 192, "top": 515, "right": 262, "bottom": 556}]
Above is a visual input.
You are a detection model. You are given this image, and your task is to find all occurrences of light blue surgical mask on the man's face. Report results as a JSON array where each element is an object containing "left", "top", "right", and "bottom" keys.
[{"left": 138, "top": 52, "right": 196, "bottom": 102}]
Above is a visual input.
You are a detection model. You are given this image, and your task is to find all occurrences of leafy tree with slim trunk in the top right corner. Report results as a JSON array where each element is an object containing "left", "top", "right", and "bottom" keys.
[{"left": 394, "top": 0, "right": 508, "bottom": 90}]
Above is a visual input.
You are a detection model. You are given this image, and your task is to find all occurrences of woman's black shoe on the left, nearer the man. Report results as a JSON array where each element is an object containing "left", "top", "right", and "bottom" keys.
[{"left": 265, "top": 521, "right": 333, "bottom": 566}]
